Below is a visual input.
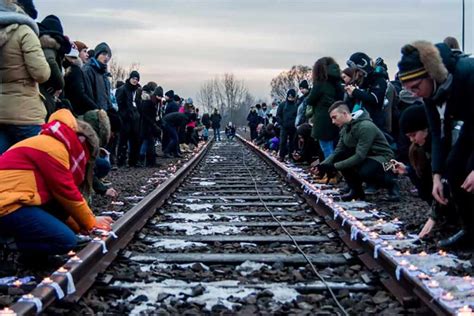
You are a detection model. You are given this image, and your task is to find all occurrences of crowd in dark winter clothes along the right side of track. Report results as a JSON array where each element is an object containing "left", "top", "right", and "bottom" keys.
[{"left": 247, "top": 37, "right": 474, "bottom": 248}]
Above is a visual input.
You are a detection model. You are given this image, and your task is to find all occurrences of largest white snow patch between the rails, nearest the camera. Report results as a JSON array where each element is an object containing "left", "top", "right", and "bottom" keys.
[{"left": 114, "top": 280, "right": 299, "bottom": 315}]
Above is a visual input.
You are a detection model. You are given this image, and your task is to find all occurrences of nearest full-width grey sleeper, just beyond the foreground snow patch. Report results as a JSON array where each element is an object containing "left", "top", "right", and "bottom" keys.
[{"left": 132, "top": 253, "right": 348, "bottom": 266}]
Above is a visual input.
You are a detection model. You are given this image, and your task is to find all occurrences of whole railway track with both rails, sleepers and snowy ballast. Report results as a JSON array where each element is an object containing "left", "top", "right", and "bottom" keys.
[{"left": 5, "top": 137, "right": 470, "bottom": 315}]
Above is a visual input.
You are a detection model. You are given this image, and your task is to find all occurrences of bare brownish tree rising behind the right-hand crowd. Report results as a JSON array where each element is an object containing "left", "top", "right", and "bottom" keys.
[{"left": 270, "top": 65, "right": 311, "bottom": 99}]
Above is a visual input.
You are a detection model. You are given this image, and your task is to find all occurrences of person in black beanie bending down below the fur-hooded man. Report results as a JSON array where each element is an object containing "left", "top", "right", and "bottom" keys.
[{"left": 389, "top": 105, "right": 454, "bottom": 238}]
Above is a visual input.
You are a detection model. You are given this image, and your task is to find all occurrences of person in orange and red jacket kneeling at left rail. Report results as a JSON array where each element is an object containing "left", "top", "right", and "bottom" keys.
[{"left": 0, "top": 109, "right": 112, "bottom": 261}]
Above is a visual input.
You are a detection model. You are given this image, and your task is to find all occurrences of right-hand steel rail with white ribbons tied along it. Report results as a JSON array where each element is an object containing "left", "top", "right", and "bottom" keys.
[{"left": 237, "top": 135, "right": 453, "bottom": 315}]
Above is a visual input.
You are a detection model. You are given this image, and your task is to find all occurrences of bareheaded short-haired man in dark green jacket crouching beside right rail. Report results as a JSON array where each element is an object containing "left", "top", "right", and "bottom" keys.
[{"left": 316, "top": 101, "right": 400, "bottom": 201}]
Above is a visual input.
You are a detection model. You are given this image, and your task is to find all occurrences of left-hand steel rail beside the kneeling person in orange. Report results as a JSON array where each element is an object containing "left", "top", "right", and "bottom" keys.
[{"left": 10, "top": 141, "right": 212, "bottom": 315}]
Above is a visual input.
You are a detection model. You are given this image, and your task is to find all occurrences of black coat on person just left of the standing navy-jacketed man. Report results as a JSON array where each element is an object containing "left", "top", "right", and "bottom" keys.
[{"left": 64, "top": 64, "right": 98, "bottom": 115}]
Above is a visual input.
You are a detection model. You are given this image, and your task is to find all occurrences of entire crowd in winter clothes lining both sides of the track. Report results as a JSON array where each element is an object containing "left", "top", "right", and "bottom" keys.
[{"left": 0, "top": 0, "right": 474, "bottom": 261}]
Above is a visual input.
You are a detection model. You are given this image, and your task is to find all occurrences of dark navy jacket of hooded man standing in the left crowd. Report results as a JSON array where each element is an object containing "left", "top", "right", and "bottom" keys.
[{"left": 82, "top": 58, "right": 112, "bottom": 111}]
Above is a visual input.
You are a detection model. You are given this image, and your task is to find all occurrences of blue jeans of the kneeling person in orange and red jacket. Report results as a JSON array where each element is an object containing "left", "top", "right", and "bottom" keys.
[{"left": 0, "top": 206, "right": 77, "bottom": 255}]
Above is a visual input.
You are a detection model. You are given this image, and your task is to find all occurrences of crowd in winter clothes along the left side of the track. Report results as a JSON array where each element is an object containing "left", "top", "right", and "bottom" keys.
[{"left": 0, "top": 0, "right": 221, "bottom": 261}]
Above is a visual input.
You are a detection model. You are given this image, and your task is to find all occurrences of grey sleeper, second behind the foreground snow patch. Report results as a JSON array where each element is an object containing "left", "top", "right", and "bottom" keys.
[{"left": 144, "top": 235, "right": 331, "bottom": 244}]
